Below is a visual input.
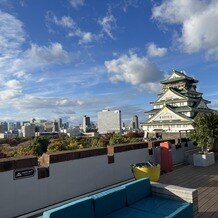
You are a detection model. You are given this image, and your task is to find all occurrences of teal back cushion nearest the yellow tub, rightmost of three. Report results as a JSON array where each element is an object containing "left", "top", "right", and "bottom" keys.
[{"left": 124, "top": 178, "right": 151, "bottom": 205}]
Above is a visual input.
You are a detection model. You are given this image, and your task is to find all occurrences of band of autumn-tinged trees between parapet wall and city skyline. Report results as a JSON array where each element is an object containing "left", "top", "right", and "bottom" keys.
[{"left": 0, "top": 133, "right": 143, "bottom": 158}]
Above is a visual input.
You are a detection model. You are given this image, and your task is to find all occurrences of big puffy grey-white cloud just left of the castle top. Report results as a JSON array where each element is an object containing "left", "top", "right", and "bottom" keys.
[{"left": 105, "top": 53, "right": 164, "bottom": 92}]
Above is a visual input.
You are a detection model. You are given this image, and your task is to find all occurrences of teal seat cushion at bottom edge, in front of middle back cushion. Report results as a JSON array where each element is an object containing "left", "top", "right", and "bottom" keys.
[{"left": 104, "top": 207, "right": 163, "bottom": 218}]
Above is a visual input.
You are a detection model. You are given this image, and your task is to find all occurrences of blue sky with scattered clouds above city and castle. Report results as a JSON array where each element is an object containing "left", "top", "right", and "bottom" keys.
[{"left": 0, "top": 0, "right": 218, "bottom": 125}]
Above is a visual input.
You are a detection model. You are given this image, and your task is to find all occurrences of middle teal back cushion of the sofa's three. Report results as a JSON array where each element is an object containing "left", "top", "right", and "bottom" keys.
[{"left": 92, "top": 187, "right": 126, "bottom": 218}]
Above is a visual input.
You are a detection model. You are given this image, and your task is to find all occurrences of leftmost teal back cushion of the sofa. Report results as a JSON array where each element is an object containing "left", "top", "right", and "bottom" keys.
[{"left": 43, "top": 197, "right": 95, "bottom": 218}]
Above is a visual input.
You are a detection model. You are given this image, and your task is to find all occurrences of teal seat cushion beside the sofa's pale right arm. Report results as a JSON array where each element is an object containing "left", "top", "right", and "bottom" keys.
[{"left": 130, "top": 196, "right": 193, "bottom": 218}]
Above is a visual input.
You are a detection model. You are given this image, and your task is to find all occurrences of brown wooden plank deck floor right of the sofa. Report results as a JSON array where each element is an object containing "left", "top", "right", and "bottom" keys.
[{"left": 159, "top": 161, "right": 218, "bottom": 218}]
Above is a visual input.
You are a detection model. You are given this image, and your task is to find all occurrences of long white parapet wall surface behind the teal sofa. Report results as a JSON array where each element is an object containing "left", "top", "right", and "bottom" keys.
[{"left": 0, "top": 142, "right": 194, "bottom": 218}]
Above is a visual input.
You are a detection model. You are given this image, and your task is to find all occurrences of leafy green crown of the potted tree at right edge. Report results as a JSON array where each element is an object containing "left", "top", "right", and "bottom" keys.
[{"left": 189, "top": 112, "right": 218, "bottom": 152}]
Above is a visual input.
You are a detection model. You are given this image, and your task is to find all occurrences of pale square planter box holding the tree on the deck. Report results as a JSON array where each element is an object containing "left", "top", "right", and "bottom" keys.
[{"left": 193, "top": 152, "right": 215, "bottom": 167}]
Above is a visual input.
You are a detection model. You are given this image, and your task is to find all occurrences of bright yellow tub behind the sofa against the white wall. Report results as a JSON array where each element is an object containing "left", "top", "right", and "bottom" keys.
[{"left": 132, "top": 164, "right": 160, "bottom": 182}]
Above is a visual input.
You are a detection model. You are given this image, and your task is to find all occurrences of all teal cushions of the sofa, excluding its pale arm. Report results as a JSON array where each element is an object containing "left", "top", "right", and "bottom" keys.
[{"left": 43, "top": 179, "right": 193, "bottom": 218}]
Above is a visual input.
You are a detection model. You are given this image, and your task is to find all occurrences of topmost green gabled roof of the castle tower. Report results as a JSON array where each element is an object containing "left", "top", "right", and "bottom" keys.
[{"left": 161, "top": 70, "right": 198, "bottom": 84}]
